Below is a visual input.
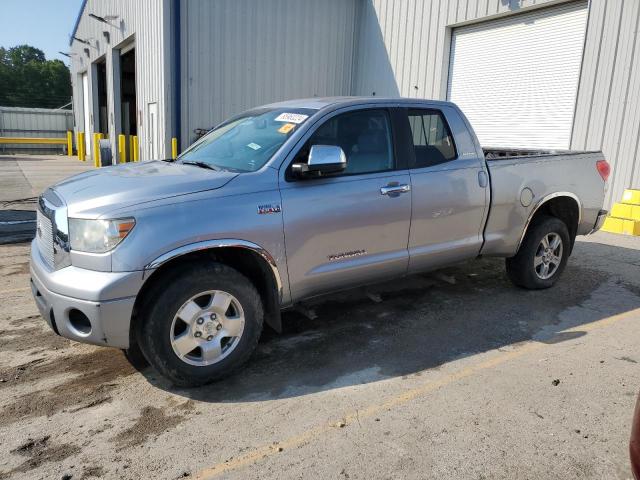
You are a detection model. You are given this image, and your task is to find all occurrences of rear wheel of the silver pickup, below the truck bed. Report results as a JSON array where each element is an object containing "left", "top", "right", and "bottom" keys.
[{"left": 505, "top": 216, "right": 571, "bottom": 290}]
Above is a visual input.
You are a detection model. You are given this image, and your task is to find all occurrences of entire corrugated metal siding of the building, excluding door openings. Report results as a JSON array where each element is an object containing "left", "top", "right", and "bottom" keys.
[{"left": 67, "top": 0, "right": 640, "bottom": 203}]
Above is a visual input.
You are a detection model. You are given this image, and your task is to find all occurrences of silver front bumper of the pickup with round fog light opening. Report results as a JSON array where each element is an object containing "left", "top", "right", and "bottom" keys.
[{"left": 31, "top": 240, "right": 144, "bottom": 348}]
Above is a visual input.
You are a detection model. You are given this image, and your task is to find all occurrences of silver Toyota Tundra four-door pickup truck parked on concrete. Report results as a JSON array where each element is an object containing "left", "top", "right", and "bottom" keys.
[{"left": 31, "top": 98, "right": 609, "bottom": 386}]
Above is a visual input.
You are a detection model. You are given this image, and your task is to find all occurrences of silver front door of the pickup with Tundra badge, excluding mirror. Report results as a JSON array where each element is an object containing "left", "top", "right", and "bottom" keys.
[{"left": 280, "top": 108, "right": 411, "bottom": 301}]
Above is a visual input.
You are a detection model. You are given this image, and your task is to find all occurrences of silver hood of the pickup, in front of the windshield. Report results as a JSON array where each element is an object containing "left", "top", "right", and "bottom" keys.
[{"left": 53, "top": 161, "right": 238, "bottom": 218}]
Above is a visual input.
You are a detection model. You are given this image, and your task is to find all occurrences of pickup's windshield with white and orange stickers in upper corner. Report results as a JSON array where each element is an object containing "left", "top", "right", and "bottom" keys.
[{"left": 177, "top": 108, "right": 315, "bottom": 172}]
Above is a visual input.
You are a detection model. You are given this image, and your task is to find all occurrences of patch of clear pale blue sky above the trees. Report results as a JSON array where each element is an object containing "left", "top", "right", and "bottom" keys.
[{"left": 0, "top": 0, "right": 82, "bottom": 65}]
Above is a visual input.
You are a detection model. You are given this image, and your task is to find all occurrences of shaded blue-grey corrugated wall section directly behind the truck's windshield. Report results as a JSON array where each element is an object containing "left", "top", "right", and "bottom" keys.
[{"left": 181, "top": 0, "right": 359, "bottom": 146}]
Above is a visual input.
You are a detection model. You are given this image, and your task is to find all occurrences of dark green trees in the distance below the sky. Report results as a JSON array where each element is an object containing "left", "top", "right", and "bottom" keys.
[{"left": 0, "top": 45, "right": 71, "bottom": 108}]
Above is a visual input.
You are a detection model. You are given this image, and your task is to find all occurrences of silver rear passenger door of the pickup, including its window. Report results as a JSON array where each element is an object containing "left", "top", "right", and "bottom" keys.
[{"left": 405, "top": 106, "right": 490, "bottom": 272}]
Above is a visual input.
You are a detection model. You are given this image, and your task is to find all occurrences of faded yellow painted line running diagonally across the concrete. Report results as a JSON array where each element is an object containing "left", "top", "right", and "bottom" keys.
[{"left": 194, "top": 308, "right": 640, "bottom": 480}]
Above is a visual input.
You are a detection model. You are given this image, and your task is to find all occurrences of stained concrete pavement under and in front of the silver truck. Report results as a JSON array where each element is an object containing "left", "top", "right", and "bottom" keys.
[{"left": 0, "top": 233, "right": 640, "bottom": 479}]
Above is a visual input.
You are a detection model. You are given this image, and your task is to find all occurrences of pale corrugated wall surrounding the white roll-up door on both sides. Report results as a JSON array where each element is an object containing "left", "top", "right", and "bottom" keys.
[{"left": 353, "top": 0, "right": 640, "bottom": 206}]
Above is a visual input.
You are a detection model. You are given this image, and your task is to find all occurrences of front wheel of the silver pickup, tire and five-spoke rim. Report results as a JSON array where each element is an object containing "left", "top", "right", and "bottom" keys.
[{"left": 136, "top": 263, "right": 264, "bottom": 387}]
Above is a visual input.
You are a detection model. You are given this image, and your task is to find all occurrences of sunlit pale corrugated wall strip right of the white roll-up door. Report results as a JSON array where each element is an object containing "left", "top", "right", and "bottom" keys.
[{"left": 571, "top": 0, "right": 640, "bottom": 206}]
